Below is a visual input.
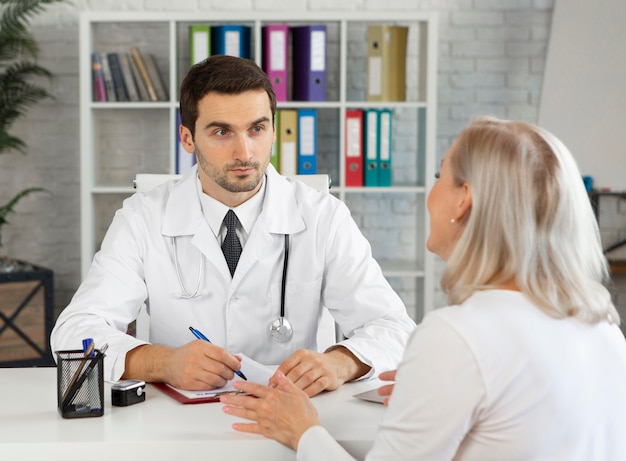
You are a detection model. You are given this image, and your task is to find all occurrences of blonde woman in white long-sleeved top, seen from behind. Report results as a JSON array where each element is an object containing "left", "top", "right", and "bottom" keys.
[{"left": 223, "top": 117, "right": 626, "bottom": 461}]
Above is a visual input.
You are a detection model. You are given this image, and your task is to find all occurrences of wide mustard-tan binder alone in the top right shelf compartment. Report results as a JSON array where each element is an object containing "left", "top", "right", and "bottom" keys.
[{"left": 367, "top": 25, "right": 409, "bottom": 101}]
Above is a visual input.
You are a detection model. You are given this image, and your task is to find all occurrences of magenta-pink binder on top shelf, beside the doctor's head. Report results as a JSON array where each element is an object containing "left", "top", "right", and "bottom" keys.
[{"left": 261, "top": 24, "right": 289, "bottom": 101}]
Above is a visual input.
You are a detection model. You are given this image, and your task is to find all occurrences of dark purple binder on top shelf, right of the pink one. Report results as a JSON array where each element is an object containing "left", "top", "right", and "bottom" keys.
[{"left": 291, "top": 24, "right": 326, "bottom": 101}]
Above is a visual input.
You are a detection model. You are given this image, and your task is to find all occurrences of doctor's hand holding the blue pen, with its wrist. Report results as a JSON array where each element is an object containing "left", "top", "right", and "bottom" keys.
[{"left": 123, "top": 340, "right": 241, "bottom": 390}]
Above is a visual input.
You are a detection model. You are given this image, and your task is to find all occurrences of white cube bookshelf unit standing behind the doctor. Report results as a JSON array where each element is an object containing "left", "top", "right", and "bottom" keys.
[{"left": 79, "top": 11, "right": 437, "bottom": 321}]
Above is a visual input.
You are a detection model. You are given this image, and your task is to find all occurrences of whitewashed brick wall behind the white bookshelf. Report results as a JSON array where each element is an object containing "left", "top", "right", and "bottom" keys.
[{"left": 0, "top": 0, "right": 553, "bottom": 316}]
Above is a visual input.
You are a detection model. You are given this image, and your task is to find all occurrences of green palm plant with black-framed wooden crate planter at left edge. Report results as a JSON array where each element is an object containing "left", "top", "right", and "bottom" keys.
[{"left": 0, "top": 0, "right": 64, "bottom": 366}]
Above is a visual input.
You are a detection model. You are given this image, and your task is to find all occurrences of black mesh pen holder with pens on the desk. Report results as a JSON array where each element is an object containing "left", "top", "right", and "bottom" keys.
[{"left": 56, "top": 350, "right": 104, "bottom": 418}]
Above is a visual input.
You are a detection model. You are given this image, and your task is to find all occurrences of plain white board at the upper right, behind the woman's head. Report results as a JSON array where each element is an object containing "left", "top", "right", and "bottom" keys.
[{"left": 538, "top": 0, "right": 626, "bottom": 191}]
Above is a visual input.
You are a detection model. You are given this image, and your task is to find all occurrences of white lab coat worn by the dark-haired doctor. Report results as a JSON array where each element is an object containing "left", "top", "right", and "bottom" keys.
[{"left": 51, "top": 165, "right": 415, "bottom": 381}]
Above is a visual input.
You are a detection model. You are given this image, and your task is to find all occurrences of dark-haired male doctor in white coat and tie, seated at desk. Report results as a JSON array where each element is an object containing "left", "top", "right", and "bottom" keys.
[{"left": 51, "top": 56, "right": 415, "bottom": 396}]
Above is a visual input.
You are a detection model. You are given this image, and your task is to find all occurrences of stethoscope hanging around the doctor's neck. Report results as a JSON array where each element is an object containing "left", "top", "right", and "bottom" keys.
[{"left": 171, "top": 234, "right": 293, "bottom": 343}]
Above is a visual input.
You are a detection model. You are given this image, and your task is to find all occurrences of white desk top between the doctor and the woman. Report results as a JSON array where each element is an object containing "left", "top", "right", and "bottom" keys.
[{"left": 0, "top": 368, "right": 385, "bottom": 461}]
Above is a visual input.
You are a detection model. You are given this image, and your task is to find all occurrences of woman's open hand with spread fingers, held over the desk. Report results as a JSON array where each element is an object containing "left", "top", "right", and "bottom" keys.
[{"left": 220, "top": 371, "right": 320, "bottom": 450}]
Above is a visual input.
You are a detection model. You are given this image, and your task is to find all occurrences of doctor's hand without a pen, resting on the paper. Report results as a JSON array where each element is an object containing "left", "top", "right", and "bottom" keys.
[{"left": 269, "top": 346, "right": 370, "bottom": 397}]
